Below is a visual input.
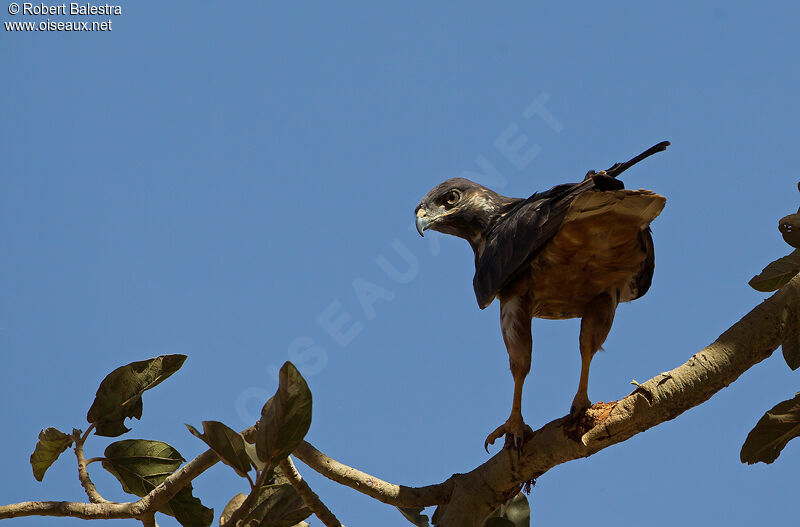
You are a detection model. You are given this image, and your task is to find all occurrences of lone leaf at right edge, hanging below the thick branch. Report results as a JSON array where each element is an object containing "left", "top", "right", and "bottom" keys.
[{"left": 739, "top": 393, "right": 800, "bottom": 465}]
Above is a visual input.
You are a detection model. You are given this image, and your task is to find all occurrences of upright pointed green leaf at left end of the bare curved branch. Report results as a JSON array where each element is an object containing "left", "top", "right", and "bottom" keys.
[{"left": 256, "top": 362, "right": 311, "bottom": 464}]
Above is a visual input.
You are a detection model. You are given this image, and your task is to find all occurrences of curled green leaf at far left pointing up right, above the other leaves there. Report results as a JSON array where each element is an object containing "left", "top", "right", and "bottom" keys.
[{"left": 86, "top": 355, "right": 186, "bottom": 437}]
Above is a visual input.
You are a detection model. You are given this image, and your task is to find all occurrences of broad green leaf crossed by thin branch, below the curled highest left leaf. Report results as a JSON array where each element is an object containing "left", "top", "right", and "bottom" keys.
[{"left": 103, "top": 439, "right": 214, "bottom": 527}]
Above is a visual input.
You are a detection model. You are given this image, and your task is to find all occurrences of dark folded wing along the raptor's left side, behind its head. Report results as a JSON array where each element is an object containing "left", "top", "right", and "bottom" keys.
[{"left": 472, "top": 178, "right": 608, "bottom": 309}]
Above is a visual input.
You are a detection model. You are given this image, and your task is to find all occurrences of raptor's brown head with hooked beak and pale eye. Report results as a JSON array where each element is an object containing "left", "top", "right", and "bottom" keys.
[{"left": 414, "top": 178, "right": 510, "bottom": 246}]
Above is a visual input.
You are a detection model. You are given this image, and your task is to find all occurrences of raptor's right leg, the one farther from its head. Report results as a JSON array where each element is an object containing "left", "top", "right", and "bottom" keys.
[{"left": 569, "top": 292, "right": 617, "bottom": 417}]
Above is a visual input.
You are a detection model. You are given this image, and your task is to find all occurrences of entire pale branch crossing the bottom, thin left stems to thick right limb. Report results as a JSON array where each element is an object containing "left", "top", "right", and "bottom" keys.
[{"left": 0, "top": 275, "right": 800, "bottom": 527}]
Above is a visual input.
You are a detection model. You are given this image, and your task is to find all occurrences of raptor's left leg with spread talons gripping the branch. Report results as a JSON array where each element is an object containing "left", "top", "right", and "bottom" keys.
[{"left": 483, "top": 297, "right": 532, "bottom": 452}]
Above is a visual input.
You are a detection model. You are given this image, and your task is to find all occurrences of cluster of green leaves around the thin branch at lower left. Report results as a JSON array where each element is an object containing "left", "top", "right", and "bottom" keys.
[{"left": 30, "top": 355, "right": 312, "bottom": 527}]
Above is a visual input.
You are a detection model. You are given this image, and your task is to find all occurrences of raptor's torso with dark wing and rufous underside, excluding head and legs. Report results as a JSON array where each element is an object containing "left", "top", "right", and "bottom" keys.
[{"left": 473, "top": 183, "right": 666, "bottom": 318}]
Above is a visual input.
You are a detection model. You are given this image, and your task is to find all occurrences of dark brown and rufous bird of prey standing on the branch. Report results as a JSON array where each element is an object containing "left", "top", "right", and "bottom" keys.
[{"left": 414, "top": 141, "right": 669, "bottom": 450}]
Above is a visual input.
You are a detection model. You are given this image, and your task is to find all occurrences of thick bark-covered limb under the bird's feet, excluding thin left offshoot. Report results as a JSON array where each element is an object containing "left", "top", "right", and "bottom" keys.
[{"left": 440, "top": 275, "right": 800, "bottom": 527}]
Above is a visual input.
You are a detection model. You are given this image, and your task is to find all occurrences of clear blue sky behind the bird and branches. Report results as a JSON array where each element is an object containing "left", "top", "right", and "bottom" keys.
[{"left": 0, "top": 0, "right": 800, "bottom": 527}]
